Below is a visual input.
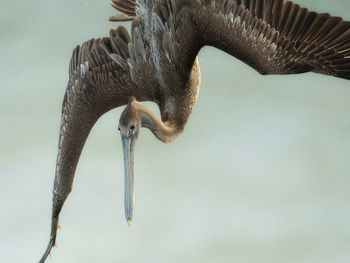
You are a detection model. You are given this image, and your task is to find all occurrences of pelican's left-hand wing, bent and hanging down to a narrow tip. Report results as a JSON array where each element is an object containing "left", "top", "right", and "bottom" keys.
[{"left": 40, "top": 27, "right": 157, "bottom": 262}]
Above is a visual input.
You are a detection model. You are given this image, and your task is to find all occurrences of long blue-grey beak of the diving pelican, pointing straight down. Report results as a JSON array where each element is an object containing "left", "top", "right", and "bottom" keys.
[{"left": 122, "top": 136, "right": 135, "bottom": 225}]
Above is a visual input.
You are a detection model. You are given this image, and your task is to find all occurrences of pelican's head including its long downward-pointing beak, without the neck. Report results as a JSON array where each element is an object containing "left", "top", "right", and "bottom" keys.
[{"left": 118, "top": 98, "right": 141, "bottom": 224}]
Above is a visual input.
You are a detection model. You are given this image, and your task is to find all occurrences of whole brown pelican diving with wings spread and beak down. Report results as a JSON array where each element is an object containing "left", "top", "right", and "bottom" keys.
[{"left": 40, "top": 0, "right": 350, "bottom": 262}]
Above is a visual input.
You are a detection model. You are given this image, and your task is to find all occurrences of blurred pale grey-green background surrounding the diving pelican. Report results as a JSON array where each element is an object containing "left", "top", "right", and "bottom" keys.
[{"left": 0, "top": 0, "right": 350, "bottom": 263}]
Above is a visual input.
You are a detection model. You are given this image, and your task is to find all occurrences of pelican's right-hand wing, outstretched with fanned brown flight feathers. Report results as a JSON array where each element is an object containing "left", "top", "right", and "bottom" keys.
[{"left": 193, "top": 0, "right": 350, "bottom": 79}]
